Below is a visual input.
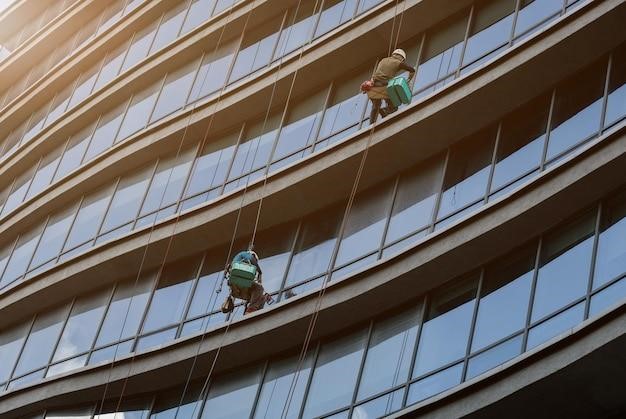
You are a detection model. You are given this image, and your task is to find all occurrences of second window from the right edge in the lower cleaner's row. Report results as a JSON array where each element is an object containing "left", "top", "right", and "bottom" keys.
[{"left": 546, "top": 63, "right": 606, "bottom": 160}]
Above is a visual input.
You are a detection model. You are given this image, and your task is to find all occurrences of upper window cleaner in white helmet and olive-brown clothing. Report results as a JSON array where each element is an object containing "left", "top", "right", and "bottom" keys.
[{"left": 367, "top": 49, "right": 415, "bottom": 124}]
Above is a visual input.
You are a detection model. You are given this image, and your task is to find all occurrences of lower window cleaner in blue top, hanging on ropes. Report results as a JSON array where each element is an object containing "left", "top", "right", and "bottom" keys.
[{"left": 222, "top": 245, "right": 271, "bottom": 314}]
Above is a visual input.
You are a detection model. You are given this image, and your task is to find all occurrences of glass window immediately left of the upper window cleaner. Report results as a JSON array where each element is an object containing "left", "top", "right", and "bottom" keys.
[{"left": 316, "top": 68, "right": 372, "bottom": 149}]
